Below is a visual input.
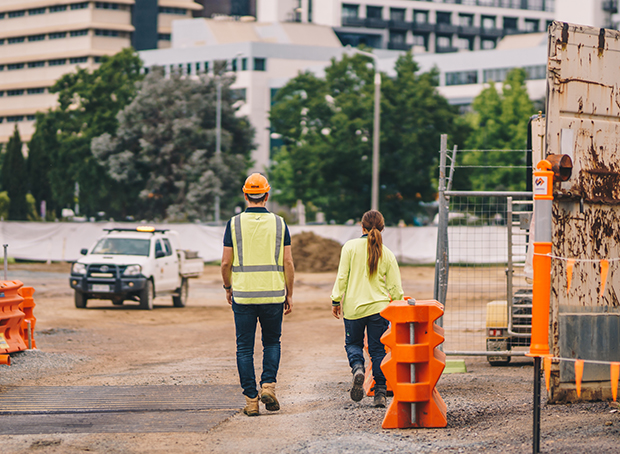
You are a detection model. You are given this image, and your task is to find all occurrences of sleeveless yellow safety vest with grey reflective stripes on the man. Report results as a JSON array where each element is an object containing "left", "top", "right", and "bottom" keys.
[{"left": 230, "top": 212, "right": 286, "bottom": 304}]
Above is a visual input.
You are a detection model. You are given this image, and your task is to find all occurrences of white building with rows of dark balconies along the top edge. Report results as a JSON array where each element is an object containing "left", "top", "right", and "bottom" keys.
[{"left": 257, "top": 0, "right": 556, "bottom": 53}]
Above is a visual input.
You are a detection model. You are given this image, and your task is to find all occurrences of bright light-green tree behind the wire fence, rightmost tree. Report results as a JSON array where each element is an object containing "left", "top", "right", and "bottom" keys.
[{"left": 462, "top": 68, "right": 534, "bottom": 191}]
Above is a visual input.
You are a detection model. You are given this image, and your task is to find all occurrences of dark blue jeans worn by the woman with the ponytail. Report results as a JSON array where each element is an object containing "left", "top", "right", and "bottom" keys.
[{"left": 344, "top": 314, "right": 389, "bottom": 386}]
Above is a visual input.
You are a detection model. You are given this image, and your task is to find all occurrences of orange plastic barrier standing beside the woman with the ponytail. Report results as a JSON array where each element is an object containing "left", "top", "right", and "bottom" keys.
[{"left": 381, "top": 300, "right": 448, "bottom": 429}]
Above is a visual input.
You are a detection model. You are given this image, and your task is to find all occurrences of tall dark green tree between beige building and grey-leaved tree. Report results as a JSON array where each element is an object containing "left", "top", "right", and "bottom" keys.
[{"left": 32, "top": 49, "right": 143, "bottom": 215}]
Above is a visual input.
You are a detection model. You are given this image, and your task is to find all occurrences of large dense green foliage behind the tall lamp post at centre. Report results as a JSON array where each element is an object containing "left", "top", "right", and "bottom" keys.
[{"left": 270, "top": 54, "right": 463, "bottom": 224}]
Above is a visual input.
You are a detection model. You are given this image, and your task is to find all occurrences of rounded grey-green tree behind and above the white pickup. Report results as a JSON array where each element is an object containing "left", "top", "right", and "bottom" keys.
[{"left": 92, "top": 69, "right": 254, "bottom": 221}]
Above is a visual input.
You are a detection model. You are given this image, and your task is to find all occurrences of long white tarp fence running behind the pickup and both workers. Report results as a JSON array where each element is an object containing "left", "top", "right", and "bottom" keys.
[{"left": 0, "top": 221, "right": 506, "bottom": 264}]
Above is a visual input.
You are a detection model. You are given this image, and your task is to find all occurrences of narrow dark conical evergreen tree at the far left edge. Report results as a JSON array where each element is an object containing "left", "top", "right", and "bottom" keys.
[{"left": 2, "top": 125, "right": 28, "bottom": 221}]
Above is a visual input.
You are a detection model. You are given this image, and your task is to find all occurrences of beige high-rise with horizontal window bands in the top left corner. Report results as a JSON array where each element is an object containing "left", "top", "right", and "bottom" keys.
[{"left": 0, "top": 0, "right": 202, "bottom": 144}]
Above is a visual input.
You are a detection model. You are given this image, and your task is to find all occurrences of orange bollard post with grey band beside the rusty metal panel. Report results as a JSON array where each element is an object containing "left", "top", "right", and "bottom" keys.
[{"left": 527, "top": 160, "right": 553, "bottom": 356}]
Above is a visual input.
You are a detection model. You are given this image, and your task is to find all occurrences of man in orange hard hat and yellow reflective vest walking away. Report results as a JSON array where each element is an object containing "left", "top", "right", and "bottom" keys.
[{"left": 222, "top": 173, "right": 295, "bottom": 416}]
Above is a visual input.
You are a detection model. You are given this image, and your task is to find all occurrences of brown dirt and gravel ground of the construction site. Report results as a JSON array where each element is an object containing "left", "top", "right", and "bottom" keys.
[{"left": 0, "top": 263, "right": 620, "bottom": 454}]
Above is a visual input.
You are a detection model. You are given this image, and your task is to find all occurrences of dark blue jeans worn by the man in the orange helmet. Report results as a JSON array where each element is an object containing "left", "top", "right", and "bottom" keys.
[{"left": 232, "top": 301, "right": 284, "bottom": 399}]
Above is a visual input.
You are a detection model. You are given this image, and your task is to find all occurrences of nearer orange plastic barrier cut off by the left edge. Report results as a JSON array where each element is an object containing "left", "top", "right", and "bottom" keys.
[{"left": 0, "top": 281, "right": 28, "bottom": 353}]
